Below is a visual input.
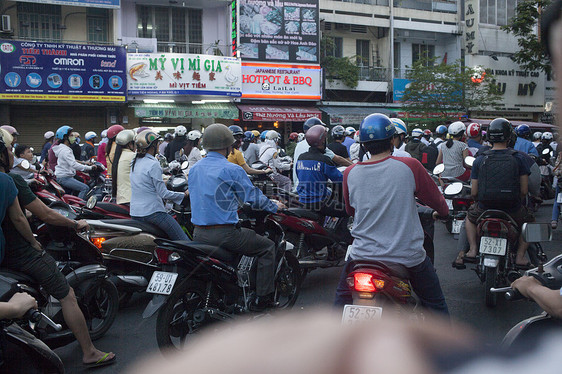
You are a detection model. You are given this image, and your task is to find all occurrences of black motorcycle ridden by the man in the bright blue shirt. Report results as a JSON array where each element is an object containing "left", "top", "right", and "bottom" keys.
[{"left": 143, "top": 209, "right": 300, "bottom": 350}]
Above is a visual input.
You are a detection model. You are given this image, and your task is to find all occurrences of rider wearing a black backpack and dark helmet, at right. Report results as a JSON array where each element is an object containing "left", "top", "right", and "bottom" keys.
[{"left": 453, "top": 118, "right": 534, "bottom": 269}]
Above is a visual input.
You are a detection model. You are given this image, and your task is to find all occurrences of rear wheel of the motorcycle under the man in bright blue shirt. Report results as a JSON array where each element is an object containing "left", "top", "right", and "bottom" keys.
[{"left": 156, "top": 280, "right": 209, "bottom": 352}]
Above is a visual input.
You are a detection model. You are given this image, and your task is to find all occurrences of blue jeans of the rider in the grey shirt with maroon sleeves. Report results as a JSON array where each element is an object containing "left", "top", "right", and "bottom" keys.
[{"left": 334, "top": 256, "right": 449, "bottom": 316}]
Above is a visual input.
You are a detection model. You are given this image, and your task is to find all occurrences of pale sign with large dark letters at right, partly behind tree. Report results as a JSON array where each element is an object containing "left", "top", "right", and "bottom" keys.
[{"left": 467, "top": 55, "right": 546, "bottom": 112}]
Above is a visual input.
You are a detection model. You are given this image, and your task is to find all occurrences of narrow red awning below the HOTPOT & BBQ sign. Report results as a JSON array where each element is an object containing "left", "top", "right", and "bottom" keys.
[{"left": 238, "top": 105, "right": 322, "bottom": 122}]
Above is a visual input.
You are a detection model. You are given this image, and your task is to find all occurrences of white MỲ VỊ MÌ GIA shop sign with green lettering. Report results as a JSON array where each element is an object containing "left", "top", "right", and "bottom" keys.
[{"left": 127, "top": 53, "right": 242, "bottom": 97}]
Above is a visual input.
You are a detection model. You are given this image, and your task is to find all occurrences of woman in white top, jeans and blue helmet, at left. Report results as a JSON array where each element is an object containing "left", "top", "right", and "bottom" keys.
[{"left": 53, "top": 126, "right": 97, "bottom": 199}]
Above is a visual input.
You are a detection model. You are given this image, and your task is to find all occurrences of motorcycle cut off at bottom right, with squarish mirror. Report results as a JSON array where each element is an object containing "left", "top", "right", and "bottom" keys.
[{"left": 486, "top": 223, "right": 562, "bottom": 354}]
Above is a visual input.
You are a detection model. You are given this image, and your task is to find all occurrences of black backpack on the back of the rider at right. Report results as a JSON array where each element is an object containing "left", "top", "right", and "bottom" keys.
[{"left": 478, "top": 149, "right": 521, "bottom": 209}]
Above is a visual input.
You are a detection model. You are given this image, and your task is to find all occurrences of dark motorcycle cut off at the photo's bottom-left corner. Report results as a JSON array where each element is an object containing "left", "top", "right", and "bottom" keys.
[{"left": 0, "top": 276, "right": 64, "bottom": 374}]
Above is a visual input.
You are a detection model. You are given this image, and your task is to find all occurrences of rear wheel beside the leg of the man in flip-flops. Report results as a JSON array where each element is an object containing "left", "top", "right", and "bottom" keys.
[{"left": 88, "top": 279, "right": 119, "bottom": 340}]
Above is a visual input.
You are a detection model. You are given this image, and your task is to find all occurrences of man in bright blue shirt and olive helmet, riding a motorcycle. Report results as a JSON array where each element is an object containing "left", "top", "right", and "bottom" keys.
[{"left": 189, "top": 124, "right": 283, "bottom": 311}]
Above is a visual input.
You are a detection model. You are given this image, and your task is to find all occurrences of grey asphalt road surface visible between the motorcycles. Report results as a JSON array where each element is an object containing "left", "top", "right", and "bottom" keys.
[{"left": 56, "top": 203, "right": 562, "bottom": 374}]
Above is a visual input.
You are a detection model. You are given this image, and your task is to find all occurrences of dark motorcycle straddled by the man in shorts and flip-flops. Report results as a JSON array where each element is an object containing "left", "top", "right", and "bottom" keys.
[{"left": 0, "top": 202, "right": 118, "bottom": 349}]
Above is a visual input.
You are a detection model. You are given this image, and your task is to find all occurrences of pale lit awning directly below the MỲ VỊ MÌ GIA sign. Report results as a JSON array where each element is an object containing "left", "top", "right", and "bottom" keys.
[{"left": 130, "top": 103, "right": 238, "bottom": 119}]
